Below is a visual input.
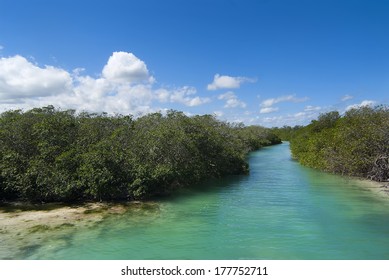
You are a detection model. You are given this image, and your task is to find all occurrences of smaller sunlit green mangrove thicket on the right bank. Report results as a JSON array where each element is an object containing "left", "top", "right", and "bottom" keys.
[{"left": 287, "top": 106, "right": 389, "bottom": 181}]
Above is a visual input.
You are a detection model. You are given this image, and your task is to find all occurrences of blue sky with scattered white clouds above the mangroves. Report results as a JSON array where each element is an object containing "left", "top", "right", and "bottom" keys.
[{"left": 0, "top": 0, "right": 389, "bottom": 127}]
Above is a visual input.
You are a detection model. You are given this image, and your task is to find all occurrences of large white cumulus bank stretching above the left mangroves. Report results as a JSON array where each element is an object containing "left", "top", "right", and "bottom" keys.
[{"left": 0, "top": 52, "right": 211, "bottom": 115}]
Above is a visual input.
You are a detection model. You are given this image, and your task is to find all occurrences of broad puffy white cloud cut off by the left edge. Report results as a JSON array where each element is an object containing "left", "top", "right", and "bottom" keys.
[{"left": 0, "top": 55, "right": 72, "bottom": 100}]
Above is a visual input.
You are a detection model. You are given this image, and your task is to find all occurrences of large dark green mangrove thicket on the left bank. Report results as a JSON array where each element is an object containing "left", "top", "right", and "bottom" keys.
[{"left": 0, "top": 106, "right": 281, "bottom": 202}]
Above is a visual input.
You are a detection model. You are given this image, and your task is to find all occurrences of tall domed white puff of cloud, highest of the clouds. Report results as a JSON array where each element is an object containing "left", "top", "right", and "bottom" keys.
[{"left": 102, "top": 52, "right": 154, "bottom": 83}]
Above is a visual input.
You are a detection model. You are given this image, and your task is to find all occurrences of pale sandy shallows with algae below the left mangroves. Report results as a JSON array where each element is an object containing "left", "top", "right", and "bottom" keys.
[{"left": 0, "top": 202, "right": 135, "bottom": 259}]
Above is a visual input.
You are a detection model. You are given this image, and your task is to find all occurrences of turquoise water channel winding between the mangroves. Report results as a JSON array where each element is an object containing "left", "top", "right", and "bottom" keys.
[{"left": 6, "top": 143, "right": 389, "bottom": 259}]
